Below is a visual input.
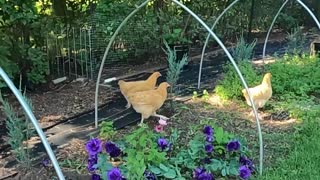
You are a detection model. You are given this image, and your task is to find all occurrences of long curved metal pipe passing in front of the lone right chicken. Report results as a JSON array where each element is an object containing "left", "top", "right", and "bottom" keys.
[{"left": 171, "top": 0, "right": 263, "bottom": 175}]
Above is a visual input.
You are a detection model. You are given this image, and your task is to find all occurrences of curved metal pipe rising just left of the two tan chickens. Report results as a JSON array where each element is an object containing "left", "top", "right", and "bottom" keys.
[{"left": 94, "top": 0, "right": 151, "bottom": 128}]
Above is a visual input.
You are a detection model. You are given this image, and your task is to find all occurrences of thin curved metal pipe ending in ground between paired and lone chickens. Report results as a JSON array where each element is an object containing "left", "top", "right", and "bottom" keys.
[{"left": 198, "top": 0, "right": 239, "bottom": 89}]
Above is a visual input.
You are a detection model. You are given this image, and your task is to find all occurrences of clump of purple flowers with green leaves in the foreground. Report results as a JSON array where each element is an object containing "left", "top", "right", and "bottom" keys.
[{"left": 86, "top": 119, "right": 255, "bottom": 180}]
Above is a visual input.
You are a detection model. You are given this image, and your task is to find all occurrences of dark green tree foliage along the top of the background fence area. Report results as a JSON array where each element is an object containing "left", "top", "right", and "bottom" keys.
[{"left": 0, "top": 0, "right": 320, "bottom": 87}]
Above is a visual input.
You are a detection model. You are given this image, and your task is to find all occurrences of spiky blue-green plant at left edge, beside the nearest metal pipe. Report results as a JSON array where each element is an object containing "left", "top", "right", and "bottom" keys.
[{"left": 0, "top": 89, "right": 35, "bottom": 168}]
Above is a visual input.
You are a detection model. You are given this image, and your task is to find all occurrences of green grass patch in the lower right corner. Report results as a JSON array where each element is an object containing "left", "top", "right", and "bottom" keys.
[{"left": 259, "top": 118, "right": 320, "bottom": 180}]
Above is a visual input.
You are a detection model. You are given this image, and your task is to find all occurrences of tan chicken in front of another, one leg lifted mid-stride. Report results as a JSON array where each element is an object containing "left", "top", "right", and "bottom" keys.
[{"left": 128, "top": 82, "right": 170, "bottom": 126}]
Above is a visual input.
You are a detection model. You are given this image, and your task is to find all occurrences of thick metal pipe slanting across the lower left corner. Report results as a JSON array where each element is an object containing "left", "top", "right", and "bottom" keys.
[{"left": 0, "top": 67, "right": 65, "bottom": 180}]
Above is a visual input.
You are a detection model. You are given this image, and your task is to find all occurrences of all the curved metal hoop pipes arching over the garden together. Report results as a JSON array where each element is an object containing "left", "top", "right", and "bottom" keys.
[{"left": 0, "top": 0, "right": 320, "bottom": 180}]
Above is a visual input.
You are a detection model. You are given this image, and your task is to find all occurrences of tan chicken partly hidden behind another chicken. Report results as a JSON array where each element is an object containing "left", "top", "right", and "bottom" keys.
[{"left": 118, "top": 72, "right": 161, "bottom": 108}]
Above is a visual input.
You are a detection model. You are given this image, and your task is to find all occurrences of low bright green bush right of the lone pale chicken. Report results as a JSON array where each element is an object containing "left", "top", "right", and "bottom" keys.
[{"left": 266, "top": 56, "right": 320, "bottom": 96}]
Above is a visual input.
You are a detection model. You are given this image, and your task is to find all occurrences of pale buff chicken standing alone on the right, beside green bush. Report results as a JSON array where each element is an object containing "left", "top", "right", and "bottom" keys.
[{"left": 242, "top": 73, "right": 272, "bottom": 119}]
